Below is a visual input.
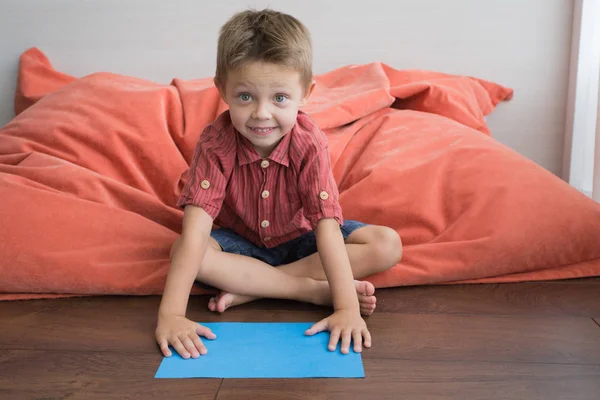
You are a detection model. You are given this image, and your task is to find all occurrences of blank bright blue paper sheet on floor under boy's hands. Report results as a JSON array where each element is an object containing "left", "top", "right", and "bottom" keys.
[{"left": 154, "top": 322, "right": 365, "bottom": 378}]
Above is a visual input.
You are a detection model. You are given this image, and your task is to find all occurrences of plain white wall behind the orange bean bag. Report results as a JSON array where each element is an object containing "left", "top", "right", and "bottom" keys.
[{"left": 0, "top": 0, "right": 573, "bottom": 174}]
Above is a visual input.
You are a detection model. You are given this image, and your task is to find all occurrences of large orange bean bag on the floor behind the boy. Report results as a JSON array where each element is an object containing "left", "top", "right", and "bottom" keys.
[{"left": 0, "top": 48, "right": 600, "bottom": 300}]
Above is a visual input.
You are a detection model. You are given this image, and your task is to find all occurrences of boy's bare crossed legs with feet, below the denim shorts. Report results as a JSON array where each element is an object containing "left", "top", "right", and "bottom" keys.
[{"left": 173, "top": 225, "right": 402, "bottom": 315}]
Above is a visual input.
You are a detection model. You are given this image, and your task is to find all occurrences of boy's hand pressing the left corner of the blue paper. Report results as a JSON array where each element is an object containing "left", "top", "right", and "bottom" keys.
[{"left": 156, "top": 315, "right": 217, "bottom": 359}]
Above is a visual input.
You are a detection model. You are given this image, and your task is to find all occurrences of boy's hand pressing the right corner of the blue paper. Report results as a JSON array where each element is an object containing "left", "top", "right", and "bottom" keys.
[{"left": 305, "top": 309, "right": 371, "bottom": 354}]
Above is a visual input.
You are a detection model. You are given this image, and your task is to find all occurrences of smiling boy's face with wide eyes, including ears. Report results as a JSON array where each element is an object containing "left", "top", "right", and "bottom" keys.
[{"left": 217, "top": 61, "right": 314, "bottom": 158}]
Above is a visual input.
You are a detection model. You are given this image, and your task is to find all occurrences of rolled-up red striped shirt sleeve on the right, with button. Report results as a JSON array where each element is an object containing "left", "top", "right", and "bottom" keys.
[{"left": 298, "top": 146, "right": 344, "bottom": 229}]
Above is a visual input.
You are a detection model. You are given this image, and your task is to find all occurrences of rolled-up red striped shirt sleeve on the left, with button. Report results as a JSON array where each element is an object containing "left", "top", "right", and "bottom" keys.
[{"left": 177, "top": 131, "right": 228, "bottom": 220}]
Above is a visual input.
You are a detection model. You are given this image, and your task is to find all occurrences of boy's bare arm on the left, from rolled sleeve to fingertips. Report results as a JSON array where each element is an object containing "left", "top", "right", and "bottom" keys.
[{"left": 156, "top": 205, "right": 215, "bottom": 358}]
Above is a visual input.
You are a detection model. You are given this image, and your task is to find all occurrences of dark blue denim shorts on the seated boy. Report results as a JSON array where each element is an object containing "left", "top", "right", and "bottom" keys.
[{"left": 210, "top": 220, "right": 367, "bottom": 267}]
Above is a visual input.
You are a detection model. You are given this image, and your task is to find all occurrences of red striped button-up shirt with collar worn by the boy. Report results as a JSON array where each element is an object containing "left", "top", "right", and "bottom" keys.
[{"left": 177, "top": 111, "right": 343, "bottom": 247}]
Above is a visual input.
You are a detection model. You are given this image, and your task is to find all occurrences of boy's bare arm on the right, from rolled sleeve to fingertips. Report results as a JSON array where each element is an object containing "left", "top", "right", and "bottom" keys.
[{"left": 306, "top": 219, "right": 371, "bottom": 354}]
